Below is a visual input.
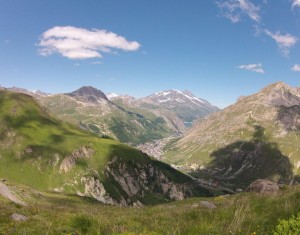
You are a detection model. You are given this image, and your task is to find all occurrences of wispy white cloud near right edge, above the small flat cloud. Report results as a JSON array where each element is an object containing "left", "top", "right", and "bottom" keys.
[{"left": 264, "top": 29, "right": 298, "bottom": 56}]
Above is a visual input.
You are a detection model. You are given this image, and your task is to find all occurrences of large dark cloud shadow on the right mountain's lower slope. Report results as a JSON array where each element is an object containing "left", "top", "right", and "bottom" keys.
[{"left": 192, "top": 125, "right": 293, "bottom": 188}]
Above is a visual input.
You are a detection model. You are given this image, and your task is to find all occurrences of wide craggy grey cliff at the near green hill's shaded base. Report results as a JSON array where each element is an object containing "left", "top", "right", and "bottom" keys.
[{"left": 77, "top": 157, "right": 197, "bottom": 207}]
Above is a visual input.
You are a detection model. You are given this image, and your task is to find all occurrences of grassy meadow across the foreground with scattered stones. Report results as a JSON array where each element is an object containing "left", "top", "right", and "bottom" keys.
[{"left": 0, "top": 182, "right": 300, "bottom": 235}]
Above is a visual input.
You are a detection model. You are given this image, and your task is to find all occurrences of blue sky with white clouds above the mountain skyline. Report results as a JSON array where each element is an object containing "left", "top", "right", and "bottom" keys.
[{"left": 0, "top": 0, "right": 300, "bottom": 108}]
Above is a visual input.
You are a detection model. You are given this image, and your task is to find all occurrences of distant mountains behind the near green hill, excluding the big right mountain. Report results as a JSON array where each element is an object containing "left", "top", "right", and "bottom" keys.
[{"left": 8, "top": 86, "right": 218, "bottom": 145}]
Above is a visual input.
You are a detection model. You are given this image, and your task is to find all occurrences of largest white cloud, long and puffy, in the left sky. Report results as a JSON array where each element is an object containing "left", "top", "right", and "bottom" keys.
[{"left": 38, "top": 26, "right": 140, "bottom": 59}]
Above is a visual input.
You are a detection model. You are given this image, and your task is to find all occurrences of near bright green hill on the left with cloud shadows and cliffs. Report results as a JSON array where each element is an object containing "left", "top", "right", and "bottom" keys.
[{"left": 0, "top": 90, "right": 210, "bottom": 206}]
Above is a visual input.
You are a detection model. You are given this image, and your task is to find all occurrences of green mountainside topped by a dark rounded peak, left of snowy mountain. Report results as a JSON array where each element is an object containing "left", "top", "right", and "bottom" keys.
[{"left": 38, "top": 87, "right": 176, "bottom": 145}]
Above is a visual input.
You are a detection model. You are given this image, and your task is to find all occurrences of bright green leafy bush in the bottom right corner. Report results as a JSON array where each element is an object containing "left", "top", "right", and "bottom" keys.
[{"left": 274, "top": 213, "right": 300, "bottom": 235}]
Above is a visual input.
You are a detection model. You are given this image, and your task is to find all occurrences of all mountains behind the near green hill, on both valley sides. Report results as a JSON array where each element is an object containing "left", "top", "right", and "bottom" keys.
[{"left": 2, "top": 82, "right": 300, "bottom": 189}]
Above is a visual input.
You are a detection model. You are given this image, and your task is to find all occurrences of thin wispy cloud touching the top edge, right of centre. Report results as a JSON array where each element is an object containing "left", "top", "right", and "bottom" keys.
[{"left": 216, "top": 0, "right": 260, "bottom": 23}]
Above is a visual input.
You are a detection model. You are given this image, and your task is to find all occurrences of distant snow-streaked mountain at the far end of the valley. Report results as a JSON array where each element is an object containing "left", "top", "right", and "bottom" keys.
[{"left": 138, "top": 89, "right": 219, "bottom": 127}]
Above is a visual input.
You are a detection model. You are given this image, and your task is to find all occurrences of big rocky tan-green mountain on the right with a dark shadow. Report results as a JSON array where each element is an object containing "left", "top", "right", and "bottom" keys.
[{"left": 165, "top": 82, "right": 300, "bottom": 187}]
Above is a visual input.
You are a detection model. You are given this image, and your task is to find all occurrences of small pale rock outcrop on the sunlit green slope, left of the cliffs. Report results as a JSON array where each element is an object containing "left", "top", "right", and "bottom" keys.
[{"left": 59, "top": 146, "right": 94, "bottom": 173}]
